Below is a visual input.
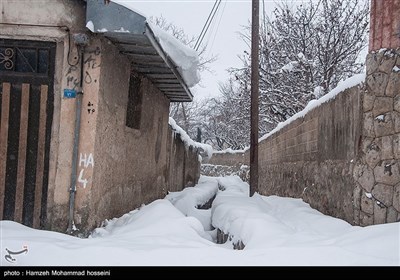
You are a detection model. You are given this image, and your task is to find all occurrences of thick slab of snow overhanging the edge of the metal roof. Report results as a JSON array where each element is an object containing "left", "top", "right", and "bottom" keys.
[{"left": 148, "top": 22, "right": 200, "bottom": 87}]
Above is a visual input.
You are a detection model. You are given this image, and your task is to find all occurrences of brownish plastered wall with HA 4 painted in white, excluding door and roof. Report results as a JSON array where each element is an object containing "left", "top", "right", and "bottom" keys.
[{"left": 0, "top": 0, "right": 199, "bottom": 234}]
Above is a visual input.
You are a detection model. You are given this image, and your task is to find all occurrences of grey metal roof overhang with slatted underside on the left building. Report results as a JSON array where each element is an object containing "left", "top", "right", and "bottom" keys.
[{"left": 86, "top": 0, "right": 193, "bottom": 102}]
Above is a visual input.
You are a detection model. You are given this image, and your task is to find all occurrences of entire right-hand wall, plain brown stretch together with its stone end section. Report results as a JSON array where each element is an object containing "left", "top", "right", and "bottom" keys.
[{"left": 259, "top": 49, "right": 400, "bottom": 226}]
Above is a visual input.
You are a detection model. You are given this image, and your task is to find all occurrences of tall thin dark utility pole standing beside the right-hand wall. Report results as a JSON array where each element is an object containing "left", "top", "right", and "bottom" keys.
[{"left": 250, "top": 0, "right": 260, "bottom": 196}]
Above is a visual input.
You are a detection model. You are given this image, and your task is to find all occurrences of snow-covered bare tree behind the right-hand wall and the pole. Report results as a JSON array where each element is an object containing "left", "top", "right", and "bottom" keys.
[{"left": 208, "top": 0, "right": 369, "bottom": 148}]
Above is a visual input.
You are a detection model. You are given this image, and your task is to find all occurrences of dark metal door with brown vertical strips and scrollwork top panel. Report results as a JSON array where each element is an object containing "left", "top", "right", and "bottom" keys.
[{"left": 0, "top": 39, "right": 55, "bottom": 228}]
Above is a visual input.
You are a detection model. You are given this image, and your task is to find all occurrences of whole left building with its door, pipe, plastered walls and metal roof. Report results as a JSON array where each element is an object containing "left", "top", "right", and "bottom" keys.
[{"left": 0, "top": 0, "right": 203, "bottom": 233}]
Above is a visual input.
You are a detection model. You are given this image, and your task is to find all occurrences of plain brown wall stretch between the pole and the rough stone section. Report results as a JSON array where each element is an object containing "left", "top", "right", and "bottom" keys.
[{"left": 259, "top": 87, "right": 361, "bottom": 222}]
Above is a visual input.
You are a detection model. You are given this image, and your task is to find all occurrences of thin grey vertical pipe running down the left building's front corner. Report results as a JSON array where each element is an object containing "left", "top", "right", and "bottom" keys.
[{"left": 67, "top": 46, "right": 85, "bottom": 234}]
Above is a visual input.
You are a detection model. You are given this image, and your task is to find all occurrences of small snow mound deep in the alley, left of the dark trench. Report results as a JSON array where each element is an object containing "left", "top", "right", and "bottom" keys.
[{"left": 165, "top": 176, "right": 218, "bottom": 231}]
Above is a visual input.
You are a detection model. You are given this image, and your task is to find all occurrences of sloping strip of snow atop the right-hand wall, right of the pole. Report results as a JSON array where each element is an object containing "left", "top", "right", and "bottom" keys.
[{"left": 260, "top": 73, "right": 366, "bottom": 142}]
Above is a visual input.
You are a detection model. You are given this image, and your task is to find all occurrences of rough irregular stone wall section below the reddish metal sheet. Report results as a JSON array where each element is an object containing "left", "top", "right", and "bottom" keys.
[{"left": 353, "top": 49, "right": 400, "bottom": 225}]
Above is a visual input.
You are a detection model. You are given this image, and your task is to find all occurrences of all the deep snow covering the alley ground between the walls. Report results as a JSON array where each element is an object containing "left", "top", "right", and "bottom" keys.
[{"left": 0, "top": 176, "right": 400, "bottom": 266}]
